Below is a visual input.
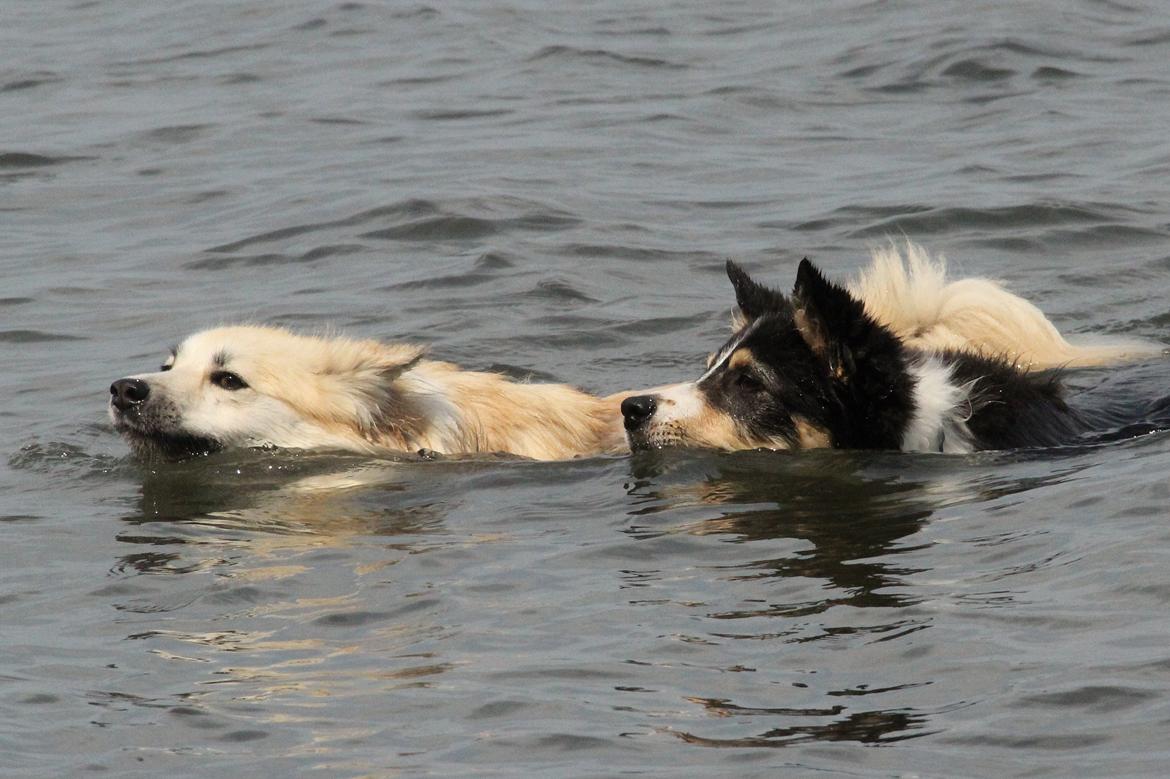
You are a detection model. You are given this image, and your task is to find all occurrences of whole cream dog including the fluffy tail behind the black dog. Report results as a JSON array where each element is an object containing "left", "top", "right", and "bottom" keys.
[{"left": 110, "top": 244, "right": 1151, "bottom": 460}]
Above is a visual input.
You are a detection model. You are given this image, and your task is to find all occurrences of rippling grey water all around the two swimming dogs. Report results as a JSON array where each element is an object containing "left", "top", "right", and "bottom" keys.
[{"left": 0, "top": 0, "right": 1170, "bottom": 777}]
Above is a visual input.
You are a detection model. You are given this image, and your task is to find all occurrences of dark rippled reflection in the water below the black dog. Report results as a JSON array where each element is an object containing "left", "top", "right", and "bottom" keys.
[{"left": 626, "top": 451, "right": 1006, "bottom": 749}]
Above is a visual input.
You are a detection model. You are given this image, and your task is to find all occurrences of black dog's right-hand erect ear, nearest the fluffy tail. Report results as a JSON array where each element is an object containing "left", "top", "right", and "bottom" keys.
[{"left": 792, "top": 257, "right": 901, "bottom": 382}]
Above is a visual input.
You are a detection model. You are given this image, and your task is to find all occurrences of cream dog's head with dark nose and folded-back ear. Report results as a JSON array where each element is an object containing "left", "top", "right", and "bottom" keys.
[{"left": 110, "top": 326, "right": 422, "bottom": 457}]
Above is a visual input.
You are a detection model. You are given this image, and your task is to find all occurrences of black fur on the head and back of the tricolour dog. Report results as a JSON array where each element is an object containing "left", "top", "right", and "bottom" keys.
[{"left": 700, "top": 260, "right": 1086, "bottom": 449}]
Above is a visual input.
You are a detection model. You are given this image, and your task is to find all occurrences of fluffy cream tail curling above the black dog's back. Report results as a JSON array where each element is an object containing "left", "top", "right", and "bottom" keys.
[{"left": 849, "top": 242, "right": 1164, "bottom": 370}]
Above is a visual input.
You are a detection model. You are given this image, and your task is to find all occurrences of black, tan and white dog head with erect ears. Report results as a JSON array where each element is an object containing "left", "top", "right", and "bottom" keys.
[{"left": 621, "top": 260, "right": 913, "bottom": 449}]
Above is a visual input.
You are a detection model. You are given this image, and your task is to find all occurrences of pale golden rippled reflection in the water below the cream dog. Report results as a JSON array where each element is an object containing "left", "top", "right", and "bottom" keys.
[{"left": 103, "top": 451, "right": 465, "bottom": 750}]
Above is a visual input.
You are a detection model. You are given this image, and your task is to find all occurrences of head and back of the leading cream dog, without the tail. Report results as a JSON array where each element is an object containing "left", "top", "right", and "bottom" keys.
[{"left": 110, "top": 326, "right": 626, "bottom": 460}]
